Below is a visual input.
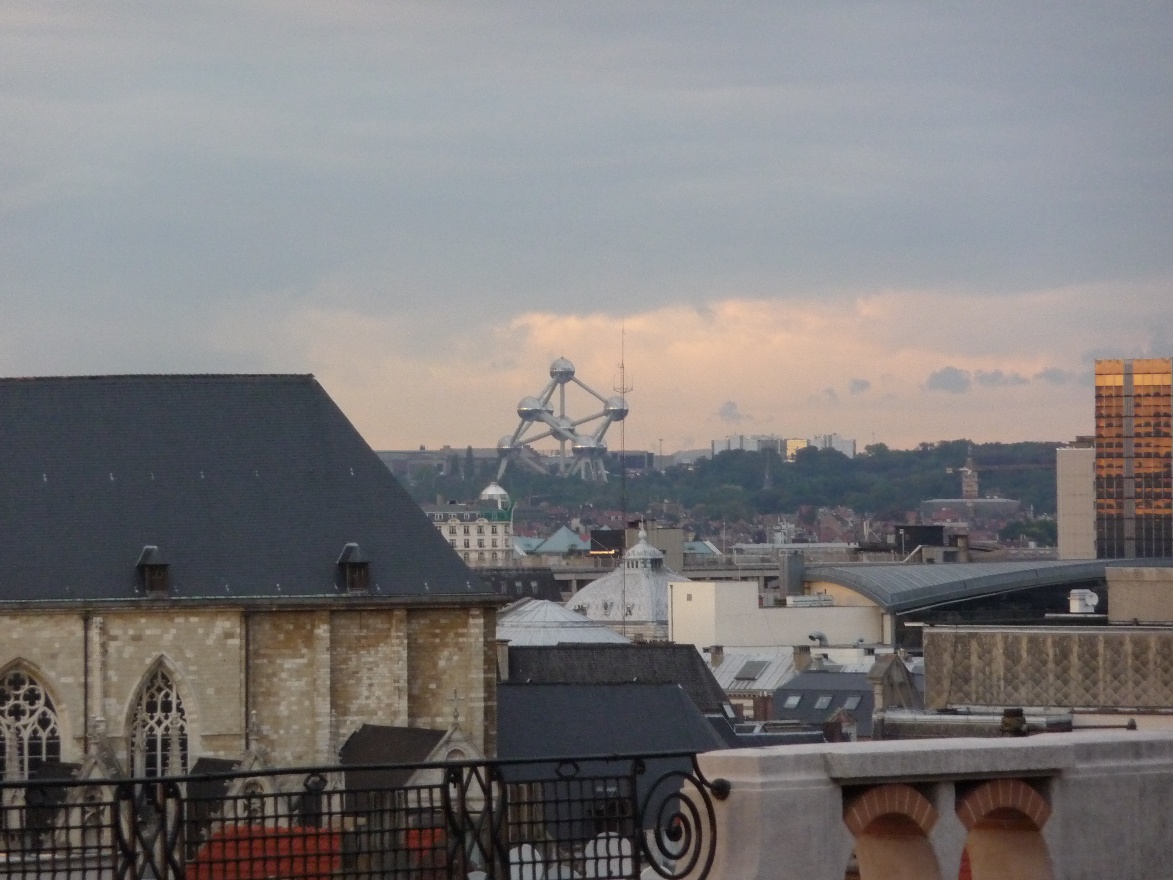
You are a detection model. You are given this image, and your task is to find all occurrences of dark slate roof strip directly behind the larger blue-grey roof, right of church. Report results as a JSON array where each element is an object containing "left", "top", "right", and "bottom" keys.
[{"left": 509, "top": 644, "right": 727, "bottom": 715}]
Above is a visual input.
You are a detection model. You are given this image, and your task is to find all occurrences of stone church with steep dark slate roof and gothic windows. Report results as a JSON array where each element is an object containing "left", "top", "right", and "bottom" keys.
[{"left": 0, "top": 375, "right": 501, "bottom": 779}]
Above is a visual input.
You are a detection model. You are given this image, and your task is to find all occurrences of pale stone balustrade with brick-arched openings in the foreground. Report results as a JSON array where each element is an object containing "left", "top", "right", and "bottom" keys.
[{"left": 698, "top": 731, "right": 1173, "bottom": 880}]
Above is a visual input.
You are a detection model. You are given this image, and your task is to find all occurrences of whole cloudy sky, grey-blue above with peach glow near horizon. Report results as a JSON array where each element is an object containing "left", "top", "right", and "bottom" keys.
[{"left": 0, "top": 0, "right": 1173, "bottom": 453}]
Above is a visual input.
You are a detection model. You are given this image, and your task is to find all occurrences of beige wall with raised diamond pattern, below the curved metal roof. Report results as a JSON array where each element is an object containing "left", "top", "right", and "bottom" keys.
[{"left": 924, "top": 628, "right": 1173, "bottom": 710}]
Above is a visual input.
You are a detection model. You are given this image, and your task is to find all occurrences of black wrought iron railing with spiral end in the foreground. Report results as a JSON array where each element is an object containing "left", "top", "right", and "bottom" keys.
[{"left": 0, "top": 752, "right": 730, "bottom": 880}]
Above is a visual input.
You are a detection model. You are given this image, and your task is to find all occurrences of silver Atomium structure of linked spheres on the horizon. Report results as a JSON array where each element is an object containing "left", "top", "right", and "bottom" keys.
[{"left": 497, "top": 358, "right": 628, "bottom": 481}]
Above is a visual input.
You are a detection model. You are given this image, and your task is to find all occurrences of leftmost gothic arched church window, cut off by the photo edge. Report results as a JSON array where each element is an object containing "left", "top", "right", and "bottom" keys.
[{"left": 0, "top": 669, "right": 61, "bottom": 779}]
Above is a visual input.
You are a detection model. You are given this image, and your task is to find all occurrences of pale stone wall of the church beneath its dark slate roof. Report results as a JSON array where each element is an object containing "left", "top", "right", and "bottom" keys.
[{"left": 0, "top": 603, "right": 496, "bottom": 766}]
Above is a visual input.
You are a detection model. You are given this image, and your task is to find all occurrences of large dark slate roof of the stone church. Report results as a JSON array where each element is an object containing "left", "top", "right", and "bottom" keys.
[{"left": 0, "top": 375, "right": 488, "bottom": 602}]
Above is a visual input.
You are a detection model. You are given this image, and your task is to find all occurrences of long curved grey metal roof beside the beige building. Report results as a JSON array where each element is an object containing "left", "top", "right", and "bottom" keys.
[{"left": 806, "top": 560, "right": 1116, "bottom": 614}]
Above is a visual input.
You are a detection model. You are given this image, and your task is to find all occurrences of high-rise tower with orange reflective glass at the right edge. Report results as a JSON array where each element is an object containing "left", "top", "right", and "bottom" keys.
[{"left": 1096, "top": 358, "right": 1173, "bottom": 559}]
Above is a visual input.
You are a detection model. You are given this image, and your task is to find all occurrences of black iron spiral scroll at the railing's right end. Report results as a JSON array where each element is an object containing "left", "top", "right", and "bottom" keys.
[{"left": 633, "top": 756, "right": 731, "bottom": 880}]
